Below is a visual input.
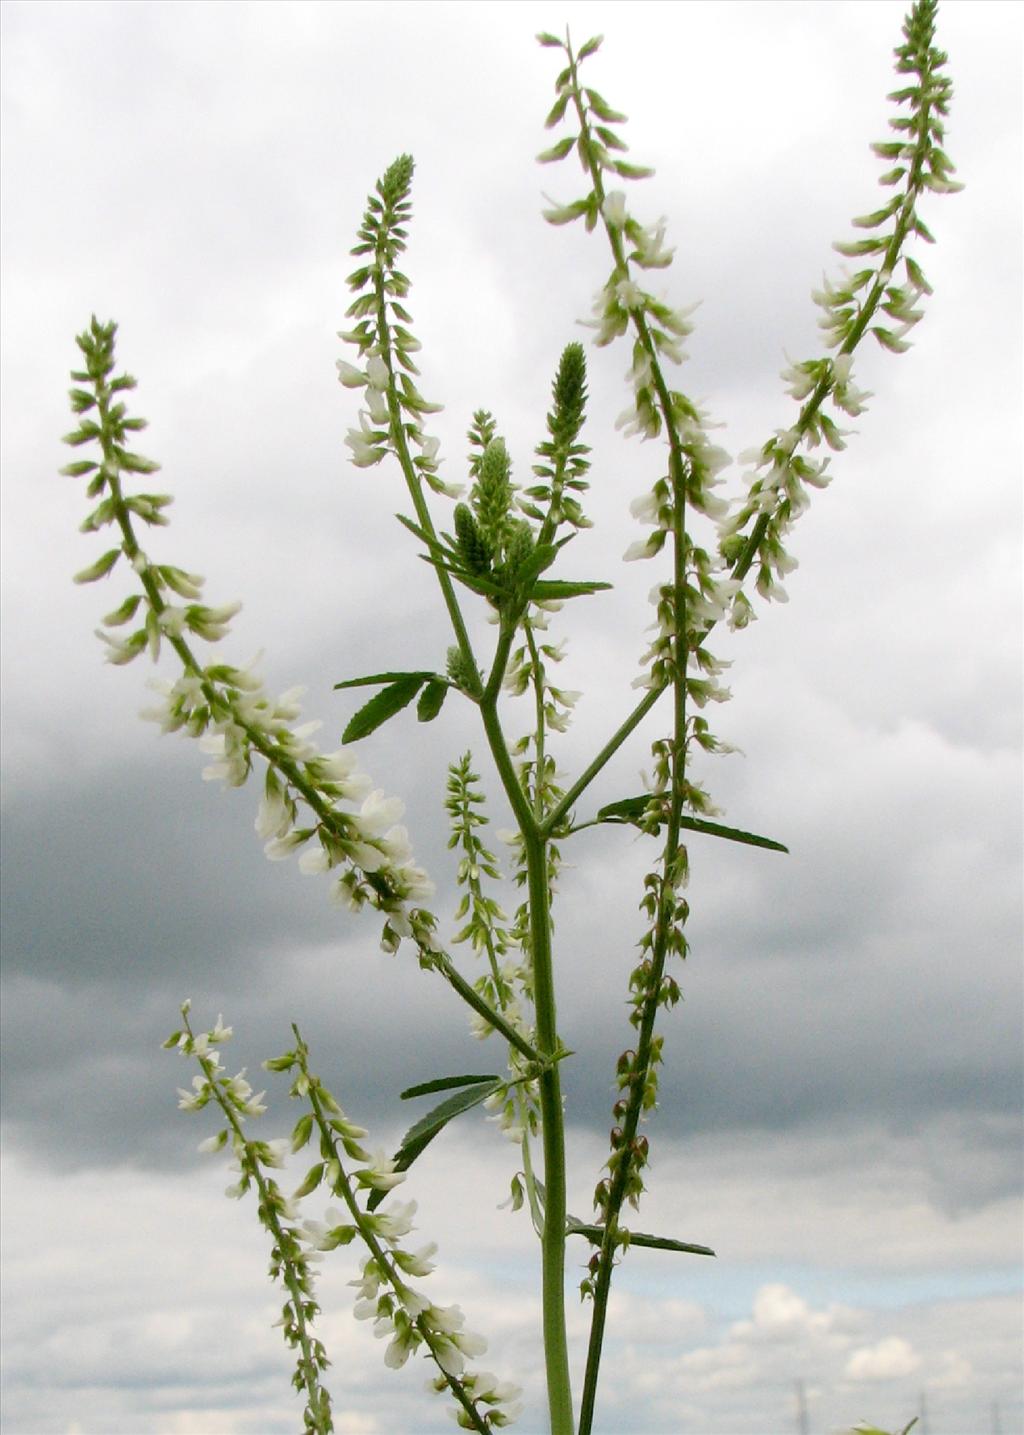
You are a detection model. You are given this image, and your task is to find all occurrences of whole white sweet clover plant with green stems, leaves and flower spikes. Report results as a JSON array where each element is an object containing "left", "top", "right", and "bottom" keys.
[{"left": 62, "top": 0, "right": 959, "bottom": 1435}]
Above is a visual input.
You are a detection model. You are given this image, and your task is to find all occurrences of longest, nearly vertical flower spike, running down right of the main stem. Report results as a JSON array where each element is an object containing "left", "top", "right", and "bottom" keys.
[{"left": 539, "top": 27, "right": 739, "bottom": 1320}]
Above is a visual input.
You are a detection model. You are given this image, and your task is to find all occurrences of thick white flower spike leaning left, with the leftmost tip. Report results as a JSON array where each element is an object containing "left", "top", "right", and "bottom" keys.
[{"left": 63, "top": 319, "right": 436, "bottom": 960}]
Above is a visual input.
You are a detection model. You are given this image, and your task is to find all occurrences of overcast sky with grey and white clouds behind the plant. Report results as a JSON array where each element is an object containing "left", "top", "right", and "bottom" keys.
[{"left": 3, "top": 0, "right": 1024, "bottom": 1435}]
